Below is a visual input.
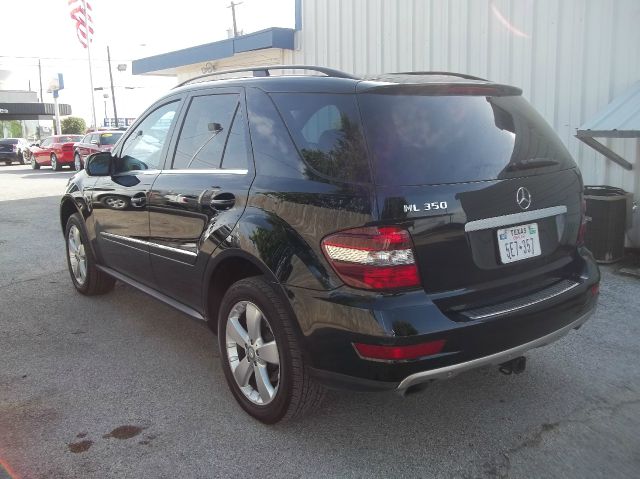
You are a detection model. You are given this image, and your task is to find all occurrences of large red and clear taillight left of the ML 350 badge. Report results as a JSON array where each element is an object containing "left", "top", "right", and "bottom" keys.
[{"left": 322, "top": 226, "right": 420, "bottom": 290}]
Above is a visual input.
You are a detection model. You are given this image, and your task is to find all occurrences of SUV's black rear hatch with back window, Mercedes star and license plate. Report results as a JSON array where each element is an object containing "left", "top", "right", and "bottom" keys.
[{"left": 358, "top": 82, "right": 582, "bottom": 308}]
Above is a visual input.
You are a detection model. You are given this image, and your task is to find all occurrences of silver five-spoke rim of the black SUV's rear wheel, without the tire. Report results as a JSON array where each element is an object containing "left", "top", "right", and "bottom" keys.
[{"left": 226, "top": 301, "right": 280, "bottom": 406}]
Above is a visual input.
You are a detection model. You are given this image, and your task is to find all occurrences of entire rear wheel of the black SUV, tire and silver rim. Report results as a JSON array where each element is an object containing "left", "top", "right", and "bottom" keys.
[{"left": 218, "top": 276, "right": 325, "bottom": 424}]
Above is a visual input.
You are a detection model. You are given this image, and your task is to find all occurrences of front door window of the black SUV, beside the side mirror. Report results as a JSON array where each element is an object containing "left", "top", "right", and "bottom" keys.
[{"left": 116, "top": 101, "right": 180, "bottom": 172}]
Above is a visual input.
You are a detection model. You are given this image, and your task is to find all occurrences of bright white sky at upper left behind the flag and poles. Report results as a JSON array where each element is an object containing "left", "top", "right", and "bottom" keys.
[{"left": 0, "top": 0, "right": 295, "bottom": 124}]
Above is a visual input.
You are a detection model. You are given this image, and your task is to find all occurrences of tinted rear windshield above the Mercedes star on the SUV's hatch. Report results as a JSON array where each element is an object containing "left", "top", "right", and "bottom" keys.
[{"left": 358, "top": 91, "right": 574, "bottom": 185}]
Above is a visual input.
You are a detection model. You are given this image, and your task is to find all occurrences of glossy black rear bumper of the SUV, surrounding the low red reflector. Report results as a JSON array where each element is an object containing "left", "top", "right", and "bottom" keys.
[{"left": 289, "top": 249, "right": 600, "bottom": 391}]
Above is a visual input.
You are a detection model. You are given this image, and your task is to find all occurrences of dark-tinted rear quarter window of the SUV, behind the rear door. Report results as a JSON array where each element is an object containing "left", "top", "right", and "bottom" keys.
[{"left": 271, "top": 93, "right": 370, "bottom": 182}]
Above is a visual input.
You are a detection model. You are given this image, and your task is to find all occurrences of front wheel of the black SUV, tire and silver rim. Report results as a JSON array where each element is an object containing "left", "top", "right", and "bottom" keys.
[{"left": 64, "top": 213, "right": 116, "bottom": 296}]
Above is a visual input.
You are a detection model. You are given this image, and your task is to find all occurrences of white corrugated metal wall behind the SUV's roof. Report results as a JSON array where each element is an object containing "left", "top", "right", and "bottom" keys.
[{"left": 291, "top": 0, "right": 640, "bottom": 198}]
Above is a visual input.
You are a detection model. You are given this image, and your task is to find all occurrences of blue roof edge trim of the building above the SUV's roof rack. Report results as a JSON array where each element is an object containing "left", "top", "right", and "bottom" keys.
[{"left": 131, "top": 27, "right": 295, "bottom": 75}]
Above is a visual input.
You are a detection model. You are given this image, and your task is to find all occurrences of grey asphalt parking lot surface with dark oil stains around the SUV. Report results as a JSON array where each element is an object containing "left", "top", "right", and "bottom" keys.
[{"left": 0, "top": 166, "right": 640, "bottom": 479}]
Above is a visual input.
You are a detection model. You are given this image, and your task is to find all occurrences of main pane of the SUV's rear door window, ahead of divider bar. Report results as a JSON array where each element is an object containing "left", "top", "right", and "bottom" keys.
[{"left": 173, "top": 94, "right": 238, "bottom": 169}]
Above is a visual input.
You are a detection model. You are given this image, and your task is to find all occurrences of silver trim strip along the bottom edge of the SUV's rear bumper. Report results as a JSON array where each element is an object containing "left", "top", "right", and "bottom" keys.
[{"left": 397, "top": 309, "right": 594, "bottom": 391}]
